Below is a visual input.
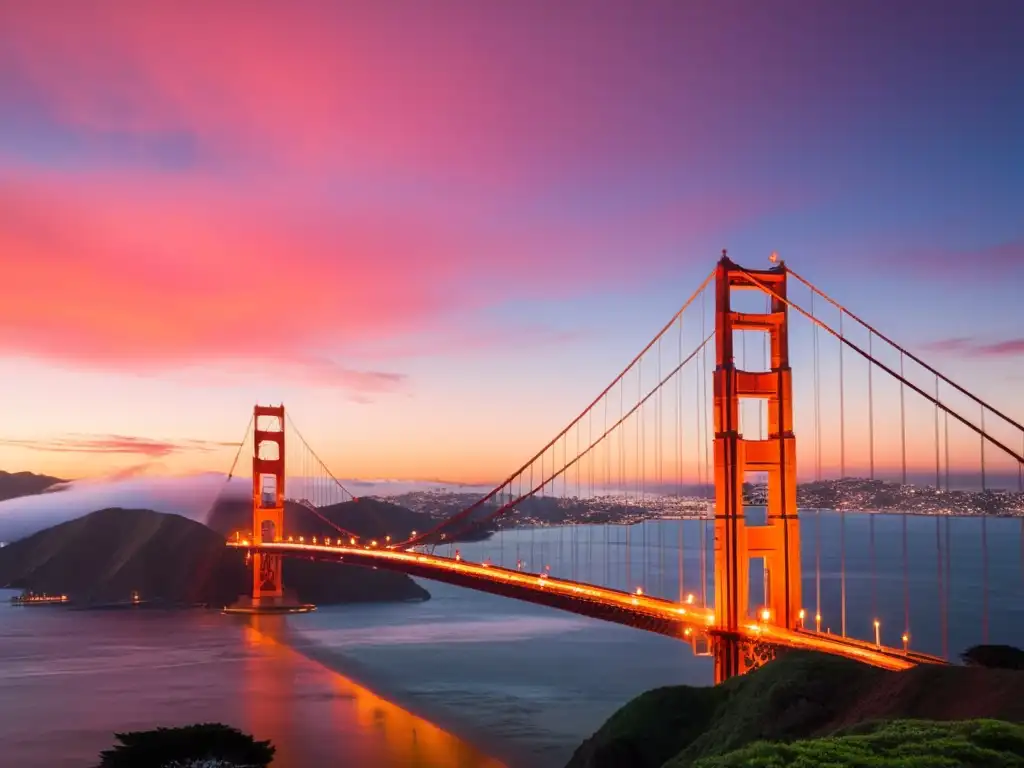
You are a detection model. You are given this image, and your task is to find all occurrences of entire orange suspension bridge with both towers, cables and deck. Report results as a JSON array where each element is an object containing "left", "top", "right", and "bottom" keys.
[{"left": 228, "top": 252, "right": 1024, "bottom": 681}]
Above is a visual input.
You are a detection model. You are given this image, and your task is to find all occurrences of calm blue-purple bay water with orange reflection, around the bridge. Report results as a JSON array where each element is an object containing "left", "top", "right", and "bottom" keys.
[{"left": 0, "top": 513, "right": 1024, "bottom": 768}]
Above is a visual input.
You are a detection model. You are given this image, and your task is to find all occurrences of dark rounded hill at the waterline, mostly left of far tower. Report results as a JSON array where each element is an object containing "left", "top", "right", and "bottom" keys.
[{"left": 0, "top": 509, "right": 429, "bottom": 605}]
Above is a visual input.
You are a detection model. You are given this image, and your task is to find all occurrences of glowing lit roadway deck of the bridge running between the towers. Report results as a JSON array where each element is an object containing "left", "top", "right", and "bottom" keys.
[{"left": 227, "top": 540, "right": 945, "bottom": 670}]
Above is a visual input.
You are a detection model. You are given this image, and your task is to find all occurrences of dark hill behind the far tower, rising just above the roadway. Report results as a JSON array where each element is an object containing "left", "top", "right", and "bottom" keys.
[{"left": 207, "top": 498, "right": 436, "bottom": 541}]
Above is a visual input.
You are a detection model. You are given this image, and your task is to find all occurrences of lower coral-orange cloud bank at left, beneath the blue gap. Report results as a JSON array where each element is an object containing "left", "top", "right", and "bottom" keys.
[{"left": 0, "top": 165, "right": 770, "bottom": 391}]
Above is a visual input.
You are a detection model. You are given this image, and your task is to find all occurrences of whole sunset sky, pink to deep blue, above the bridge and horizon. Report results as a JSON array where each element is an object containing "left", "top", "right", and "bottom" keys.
[{"left": 0, "top": 0, "right": 1024, "bottom": 482}]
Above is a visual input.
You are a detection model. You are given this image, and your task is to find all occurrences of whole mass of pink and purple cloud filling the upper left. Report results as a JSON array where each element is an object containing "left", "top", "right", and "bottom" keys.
[{"left": 0, "top": 6, "right": 793, "bottom": 397}]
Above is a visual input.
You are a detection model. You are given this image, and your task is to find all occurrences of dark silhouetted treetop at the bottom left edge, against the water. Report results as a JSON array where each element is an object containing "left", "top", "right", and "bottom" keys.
[{"left": 99, "top": 723, "right": 275, "bottom": 768}]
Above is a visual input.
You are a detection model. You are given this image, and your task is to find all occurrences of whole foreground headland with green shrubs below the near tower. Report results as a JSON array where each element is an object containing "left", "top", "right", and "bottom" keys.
[{"left": 567, "top": 651, "right": 1024, "bottom": 768}]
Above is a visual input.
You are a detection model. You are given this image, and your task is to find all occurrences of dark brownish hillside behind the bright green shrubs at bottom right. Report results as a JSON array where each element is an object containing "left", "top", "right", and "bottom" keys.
[{"left": 567, "top": 652, "right": 1024, "bottom": 768}]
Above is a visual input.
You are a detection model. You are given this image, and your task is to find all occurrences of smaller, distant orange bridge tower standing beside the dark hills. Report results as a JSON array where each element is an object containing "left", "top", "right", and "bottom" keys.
[{"left": 253, "top": 406, "right": 285, "bottom": 605}]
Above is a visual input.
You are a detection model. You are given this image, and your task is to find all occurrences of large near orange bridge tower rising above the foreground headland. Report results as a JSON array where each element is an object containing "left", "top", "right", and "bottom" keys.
[{"left": 714, "top": 252, "right": 802, "bottom": 682}]
